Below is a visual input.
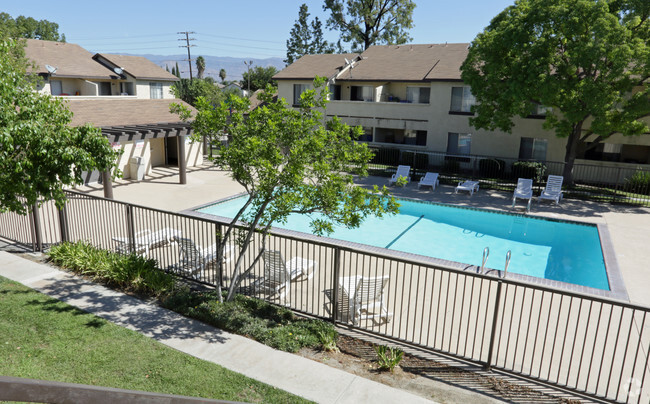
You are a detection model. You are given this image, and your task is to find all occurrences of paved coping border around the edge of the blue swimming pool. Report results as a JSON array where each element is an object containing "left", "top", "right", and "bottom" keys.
[{"left": 180, "top": 192, "right": 630, "bottom": 302}]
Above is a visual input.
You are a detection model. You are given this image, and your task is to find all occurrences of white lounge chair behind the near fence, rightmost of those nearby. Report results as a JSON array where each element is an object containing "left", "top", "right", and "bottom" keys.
[{"left": 339, "top": 275, "right": 393, "bottom": 325}]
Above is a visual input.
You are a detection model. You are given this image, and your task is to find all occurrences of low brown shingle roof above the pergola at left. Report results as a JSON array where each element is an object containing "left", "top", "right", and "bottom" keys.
[{"left": 67, "top": 97, "right": 196, "bottom": 127}]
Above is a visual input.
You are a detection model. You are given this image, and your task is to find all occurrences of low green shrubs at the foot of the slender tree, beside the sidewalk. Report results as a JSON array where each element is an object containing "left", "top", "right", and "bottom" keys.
[{"left": 162, "top": 289, "right": 336, "bottom": 352}]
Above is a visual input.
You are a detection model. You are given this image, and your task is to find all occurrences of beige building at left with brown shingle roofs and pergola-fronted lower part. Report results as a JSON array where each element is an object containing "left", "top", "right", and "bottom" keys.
[{"left": 25, "top": 39, "right": 203, "bottom": 183}]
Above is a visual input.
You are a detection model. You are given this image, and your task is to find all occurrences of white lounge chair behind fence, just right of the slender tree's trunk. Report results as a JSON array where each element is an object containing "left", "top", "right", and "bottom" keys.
[{"left": 253, "top": 250, "right": 316, "bottom": 302}]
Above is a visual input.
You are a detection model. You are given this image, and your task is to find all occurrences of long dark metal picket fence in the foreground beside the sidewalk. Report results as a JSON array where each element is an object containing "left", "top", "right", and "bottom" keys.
[{"left": 0, "top": 192, "right": 650, "bottom": 403}]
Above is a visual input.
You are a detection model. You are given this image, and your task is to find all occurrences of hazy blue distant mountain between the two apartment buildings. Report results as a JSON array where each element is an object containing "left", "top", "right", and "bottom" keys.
[{"left": 134, "top": 55, "right": 285, "bottom": 82}]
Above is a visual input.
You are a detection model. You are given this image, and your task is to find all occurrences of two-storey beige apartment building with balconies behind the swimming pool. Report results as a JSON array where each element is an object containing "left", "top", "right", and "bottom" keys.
[{"left": 274, "top": 43, "right": 650, "bottom": 180}]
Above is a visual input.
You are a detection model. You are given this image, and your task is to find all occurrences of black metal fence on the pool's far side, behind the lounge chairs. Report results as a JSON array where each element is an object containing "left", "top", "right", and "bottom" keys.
[{"left": 370, "top": 146, "right": 650, "bottom": 206}]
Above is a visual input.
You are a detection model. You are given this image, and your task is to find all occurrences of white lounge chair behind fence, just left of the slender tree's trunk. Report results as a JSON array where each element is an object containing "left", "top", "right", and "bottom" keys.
[{"left": 172, "top": 237, "right": 234, "bottom": 279}]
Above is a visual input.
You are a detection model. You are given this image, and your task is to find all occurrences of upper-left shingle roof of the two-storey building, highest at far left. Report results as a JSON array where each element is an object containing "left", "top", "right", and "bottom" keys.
[{"left": 25, "top": 39, "right": 118, "bottom": 79}]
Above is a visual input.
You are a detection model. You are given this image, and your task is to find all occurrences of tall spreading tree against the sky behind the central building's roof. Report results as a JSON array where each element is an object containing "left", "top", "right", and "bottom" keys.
[{"left": 323, "top": 0, "right": 415, "bottom": 51}]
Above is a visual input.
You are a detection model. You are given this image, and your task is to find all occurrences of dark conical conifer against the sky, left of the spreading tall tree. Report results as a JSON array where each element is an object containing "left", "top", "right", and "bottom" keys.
[{"left": 284, "top": 3, "right": 334, "bottom": 65}]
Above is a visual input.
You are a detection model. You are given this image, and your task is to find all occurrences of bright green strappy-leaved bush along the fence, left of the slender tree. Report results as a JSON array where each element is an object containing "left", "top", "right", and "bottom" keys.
[{"left": 48, "top": 241, "right": 174, "bottom": 296}]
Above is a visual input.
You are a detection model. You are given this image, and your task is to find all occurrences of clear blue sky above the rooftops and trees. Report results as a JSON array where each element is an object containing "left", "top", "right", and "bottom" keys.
[{"left": 0, "top": 0, "right": 514, "bottom": 58}]
